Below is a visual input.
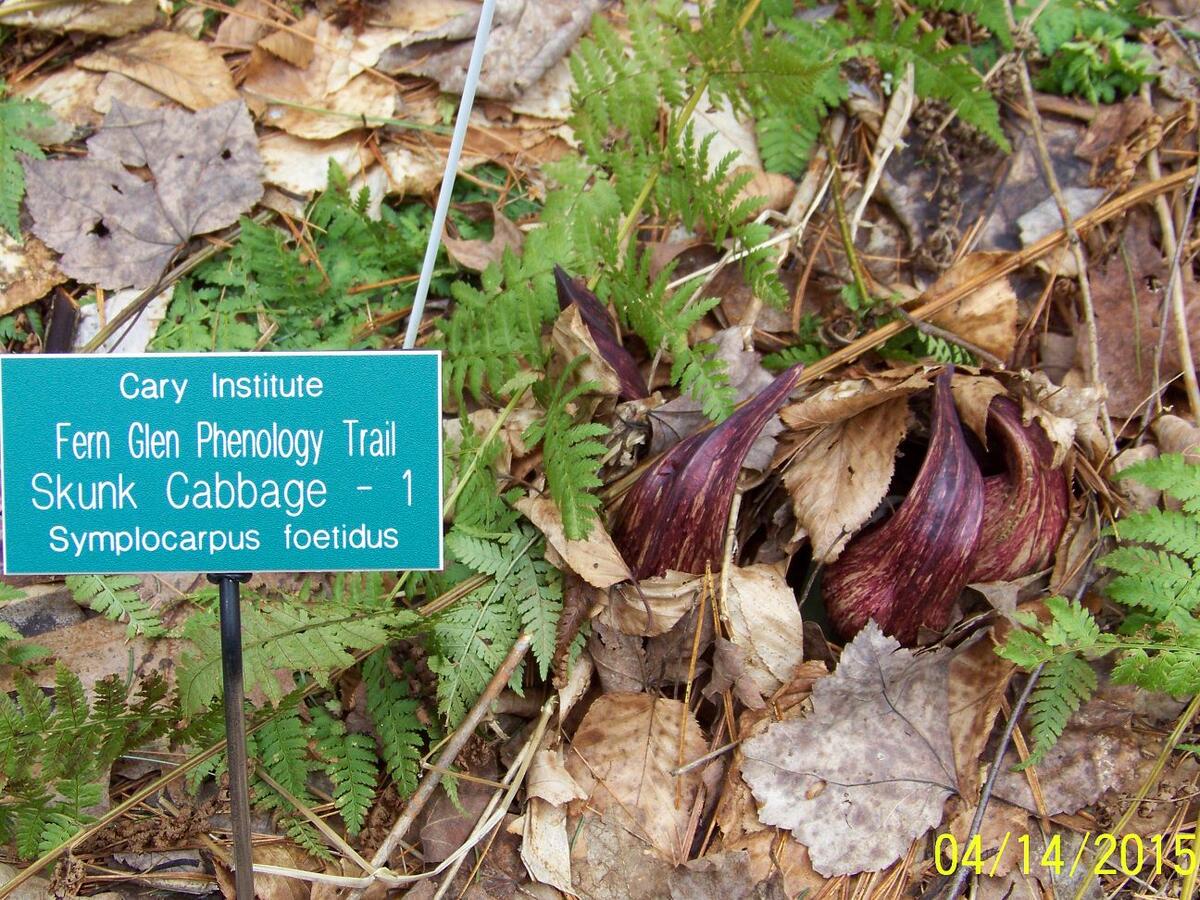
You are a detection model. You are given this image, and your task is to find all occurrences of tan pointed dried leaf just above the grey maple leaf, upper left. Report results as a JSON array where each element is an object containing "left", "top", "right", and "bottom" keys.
[{"left": 77, "top": 31, "right": 238, "bottom": 110}]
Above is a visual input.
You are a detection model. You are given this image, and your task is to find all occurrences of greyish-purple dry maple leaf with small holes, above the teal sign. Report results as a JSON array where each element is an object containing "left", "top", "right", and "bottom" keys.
[{"left": 24, "top": 101, "right": 263, "bottom": 290}]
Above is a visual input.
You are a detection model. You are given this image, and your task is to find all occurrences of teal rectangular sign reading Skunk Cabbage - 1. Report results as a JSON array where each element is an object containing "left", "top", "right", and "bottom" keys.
[{"left": 0, "top": 350, "right": 442, "bottom": 575}]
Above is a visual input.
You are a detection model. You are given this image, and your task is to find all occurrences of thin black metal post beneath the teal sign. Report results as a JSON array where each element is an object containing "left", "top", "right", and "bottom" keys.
[{"left": 209, "top": 574, "right": 254, "bottom": 898}]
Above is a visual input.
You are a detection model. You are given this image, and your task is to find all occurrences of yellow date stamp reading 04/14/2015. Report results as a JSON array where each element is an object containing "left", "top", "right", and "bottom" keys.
[{"left": 934, "top": 832, "right": 1200, "bottom": 878}]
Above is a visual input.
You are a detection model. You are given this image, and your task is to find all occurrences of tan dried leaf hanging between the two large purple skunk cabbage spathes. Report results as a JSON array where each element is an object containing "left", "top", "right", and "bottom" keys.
[{"left": 784, "top": 396, "right": 908, "bottom": 563}]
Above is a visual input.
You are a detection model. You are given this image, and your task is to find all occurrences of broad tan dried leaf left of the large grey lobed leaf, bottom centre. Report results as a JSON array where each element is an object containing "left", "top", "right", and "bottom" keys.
[{"left": 566, "top": 694, "right": 708, "bottom": 863}]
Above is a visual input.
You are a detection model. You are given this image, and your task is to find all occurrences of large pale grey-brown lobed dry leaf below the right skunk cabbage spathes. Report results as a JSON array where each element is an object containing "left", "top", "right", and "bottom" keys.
[{"left": 742, "top": 622, "right": 958, "bottom": 876}]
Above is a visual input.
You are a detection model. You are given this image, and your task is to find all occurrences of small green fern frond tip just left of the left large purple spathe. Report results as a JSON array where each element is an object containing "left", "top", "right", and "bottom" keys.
[{"left": 522, "top": 358, "right": 608, "bottom": 540}]
